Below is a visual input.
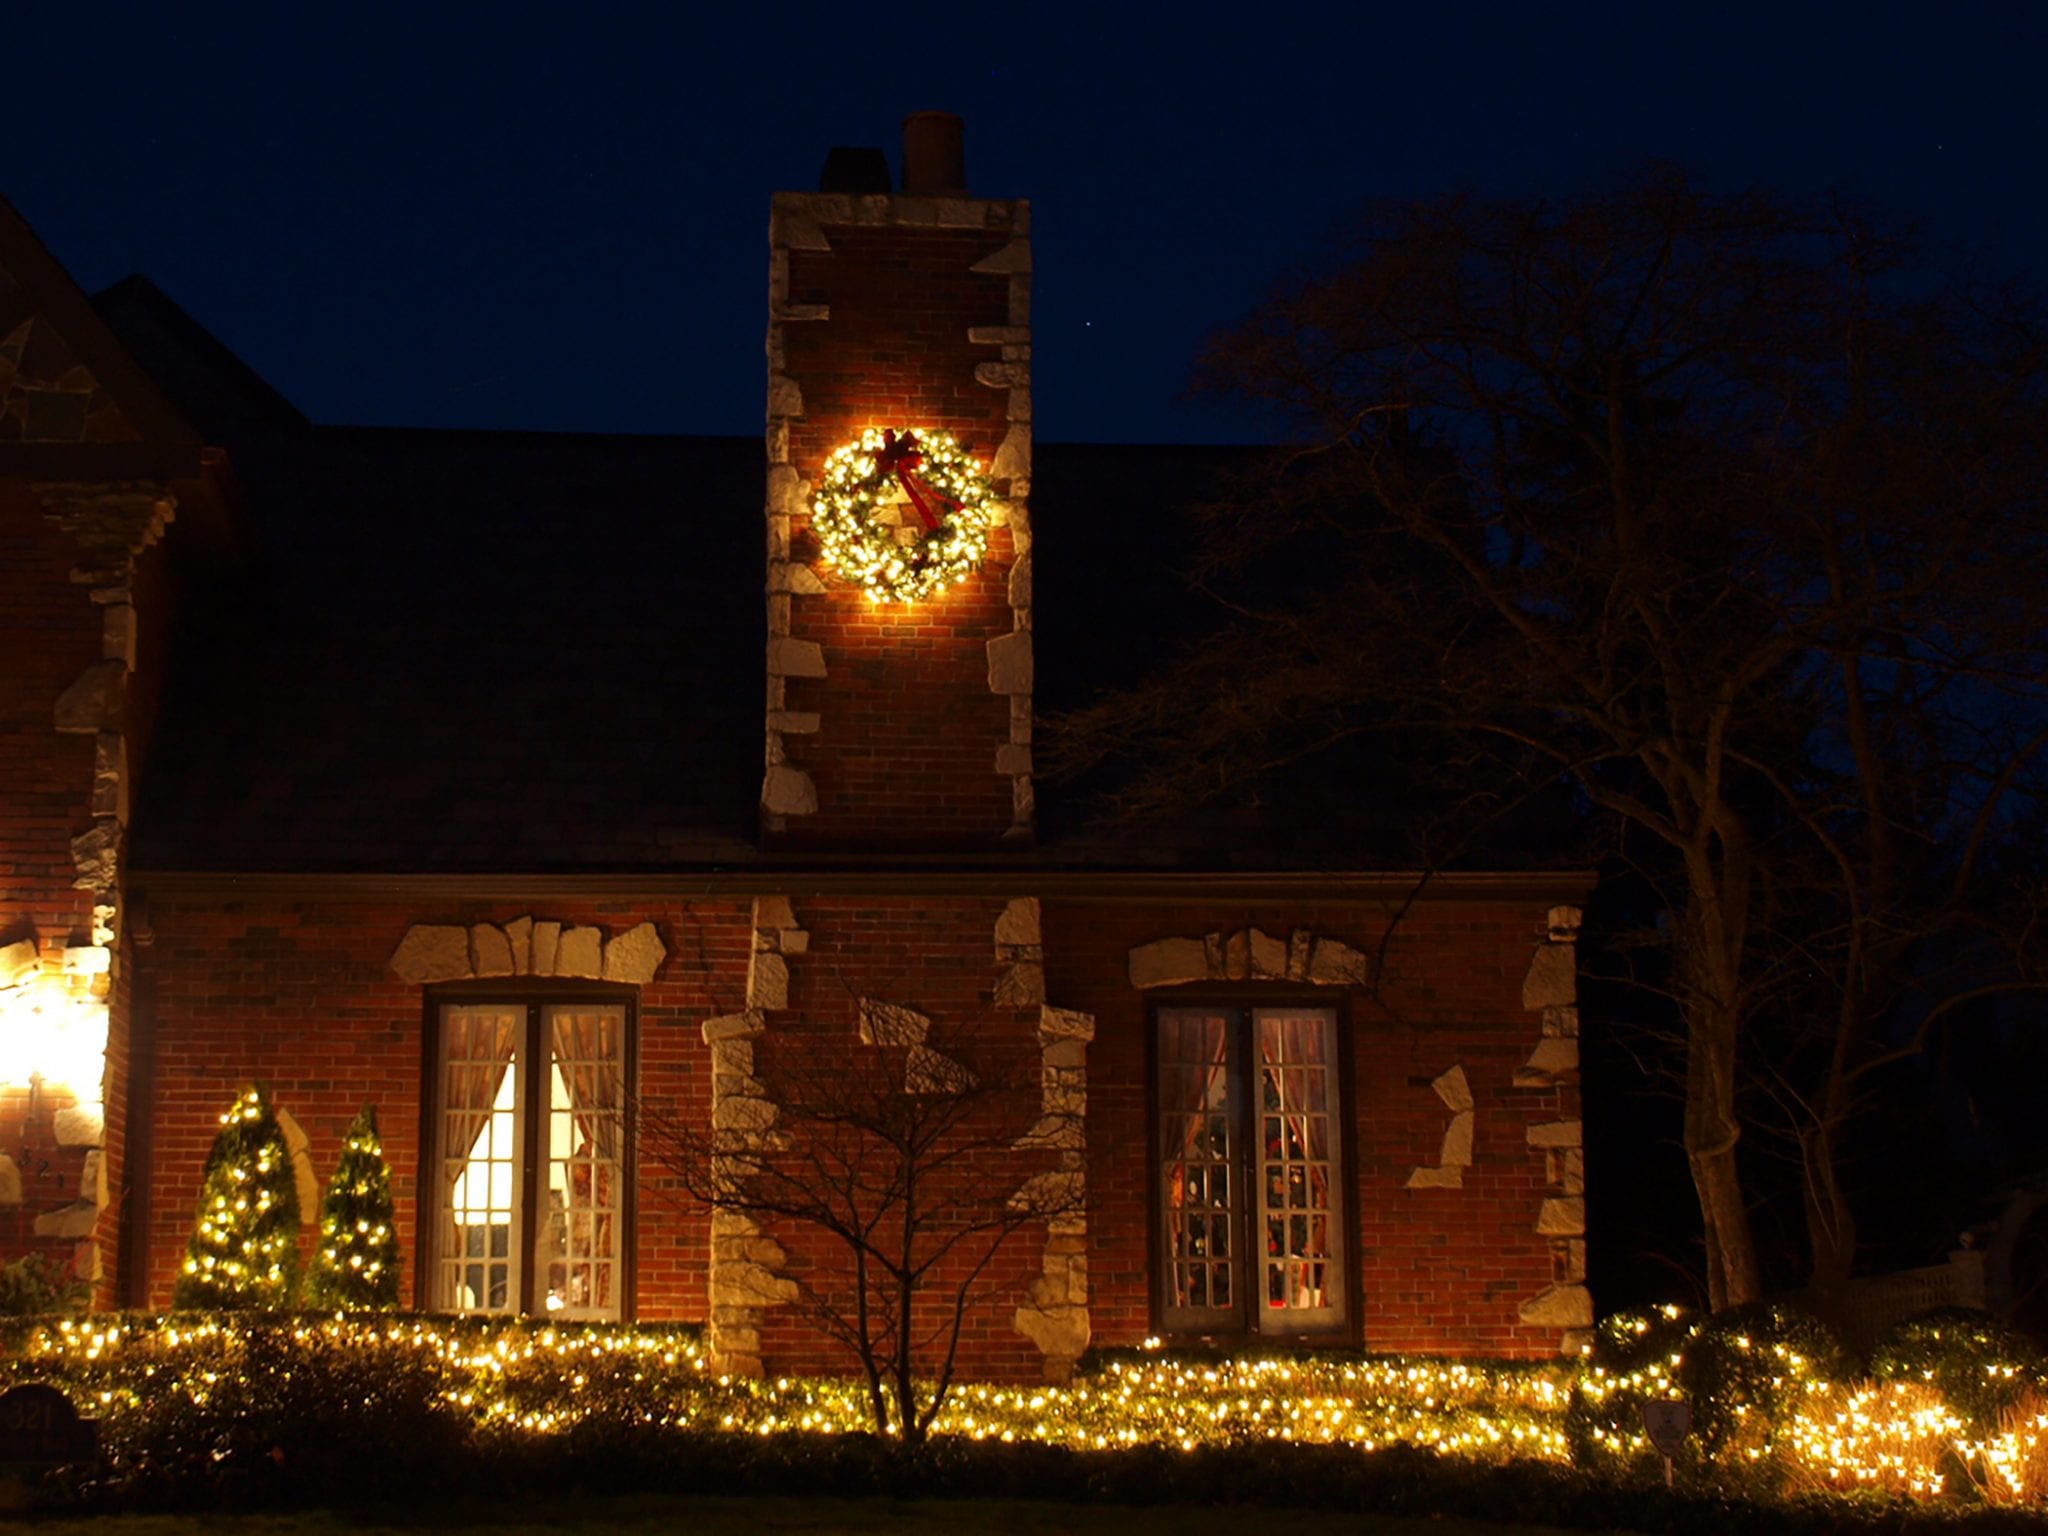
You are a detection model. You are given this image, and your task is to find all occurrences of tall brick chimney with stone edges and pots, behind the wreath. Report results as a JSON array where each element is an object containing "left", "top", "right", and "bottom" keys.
[{"left": 762, "top": 113, "right": 1034, "bottom": 854}]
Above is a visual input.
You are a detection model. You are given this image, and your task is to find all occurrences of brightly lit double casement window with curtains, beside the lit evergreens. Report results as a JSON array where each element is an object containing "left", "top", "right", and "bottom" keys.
[{"left": 422, "top": 997, "right": 631, "bottom": 1319}]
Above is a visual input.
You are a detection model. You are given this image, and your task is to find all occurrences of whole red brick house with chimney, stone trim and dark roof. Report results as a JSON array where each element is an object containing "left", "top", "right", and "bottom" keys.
[{"left": 0, "top": 117, "right": 1591, "bottom": 1380}]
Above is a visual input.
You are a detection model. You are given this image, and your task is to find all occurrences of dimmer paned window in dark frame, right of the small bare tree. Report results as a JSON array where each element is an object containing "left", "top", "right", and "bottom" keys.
[{"left": 1157, "top": 1008, "right": 1346, "bottom": 1333}]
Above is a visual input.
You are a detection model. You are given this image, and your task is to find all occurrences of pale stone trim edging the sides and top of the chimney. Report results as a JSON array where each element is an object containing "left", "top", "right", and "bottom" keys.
[{"left": 760, "top": 193, "right": 1038, "bottom": 840}]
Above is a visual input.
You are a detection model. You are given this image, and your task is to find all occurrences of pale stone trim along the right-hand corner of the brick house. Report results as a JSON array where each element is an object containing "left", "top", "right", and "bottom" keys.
[{"left": 1516, "top": 907, "right": 1593, "bottom": 1354}]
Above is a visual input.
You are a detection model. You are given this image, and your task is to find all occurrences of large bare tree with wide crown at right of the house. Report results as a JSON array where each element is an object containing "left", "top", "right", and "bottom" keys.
[{"left": 1057, "top": 170, "right": 2048, "bottom": 1309}]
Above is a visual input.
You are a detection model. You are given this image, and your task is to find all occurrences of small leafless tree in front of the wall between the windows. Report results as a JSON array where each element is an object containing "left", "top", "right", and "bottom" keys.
[{"left": 639, "top": 999, "right": 1081, "bottom": 1446}]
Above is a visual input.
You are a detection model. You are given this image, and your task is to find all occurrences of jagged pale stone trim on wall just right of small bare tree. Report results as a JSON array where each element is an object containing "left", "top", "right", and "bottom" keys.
[{"left": 995, "top": 897, "right": 1096, "bottom": 1382}]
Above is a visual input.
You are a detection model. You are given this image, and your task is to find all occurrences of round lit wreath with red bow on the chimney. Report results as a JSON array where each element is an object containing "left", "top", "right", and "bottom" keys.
[{"left": 811, "top": 426, "right": 991, "bottom": 602}]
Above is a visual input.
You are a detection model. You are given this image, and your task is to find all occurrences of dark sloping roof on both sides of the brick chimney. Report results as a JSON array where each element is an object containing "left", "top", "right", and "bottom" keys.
[{"left": 108, "top": 279, "right": 1581, "bottom": 877}]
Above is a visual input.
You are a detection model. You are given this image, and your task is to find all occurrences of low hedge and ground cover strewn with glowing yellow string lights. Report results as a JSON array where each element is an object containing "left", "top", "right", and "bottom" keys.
[{"left": 0, "top": 1309, "right": 2048, "bottom": 1530}]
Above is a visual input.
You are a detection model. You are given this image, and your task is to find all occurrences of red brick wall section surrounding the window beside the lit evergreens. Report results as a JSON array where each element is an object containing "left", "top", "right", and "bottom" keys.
[{"left": 127, "top": 897, "right": 750, "bottom": 1319}]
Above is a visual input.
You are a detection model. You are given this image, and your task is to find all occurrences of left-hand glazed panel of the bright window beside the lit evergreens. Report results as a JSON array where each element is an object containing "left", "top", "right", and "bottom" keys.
[{"left": 436, "top": 1008, "right": 524, "bottom": 1313}]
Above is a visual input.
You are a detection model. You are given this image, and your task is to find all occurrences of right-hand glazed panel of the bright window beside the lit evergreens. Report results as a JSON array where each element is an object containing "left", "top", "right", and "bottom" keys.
[{"left": 539, "top": 1006, "right": 625, "bottom": 1317}]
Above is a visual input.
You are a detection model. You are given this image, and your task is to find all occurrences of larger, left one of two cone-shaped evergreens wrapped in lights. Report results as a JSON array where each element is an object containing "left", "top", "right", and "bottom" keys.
[{"left": 172, "top": 1085, "right": 299, "bottom": 1309}]
